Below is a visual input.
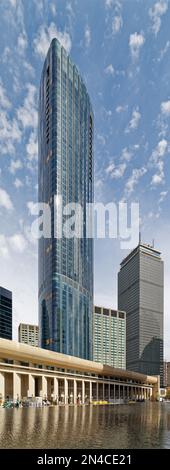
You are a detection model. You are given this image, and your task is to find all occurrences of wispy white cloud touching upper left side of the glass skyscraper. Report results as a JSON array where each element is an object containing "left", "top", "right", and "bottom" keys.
[{"left": 17, "top": 83, "right": 38, "bottom": 129}]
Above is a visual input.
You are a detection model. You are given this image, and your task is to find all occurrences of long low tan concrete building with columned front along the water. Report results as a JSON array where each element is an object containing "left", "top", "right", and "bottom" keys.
[{"left": 0, "top": 339, "right": 159, "bottom": 404}]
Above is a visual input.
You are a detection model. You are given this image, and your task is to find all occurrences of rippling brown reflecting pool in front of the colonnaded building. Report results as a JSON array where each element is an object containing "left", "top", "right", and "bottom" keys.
[{"left": 0, "top": 403, "right": 170, "bottom": 449}]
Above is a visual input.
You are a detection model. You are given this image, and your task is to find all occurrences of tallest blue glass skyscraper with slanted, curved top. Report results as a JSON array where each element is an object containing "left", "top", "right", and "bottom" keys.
[{"left": 39, "top": 39, "right": 93, "bottom": 359}]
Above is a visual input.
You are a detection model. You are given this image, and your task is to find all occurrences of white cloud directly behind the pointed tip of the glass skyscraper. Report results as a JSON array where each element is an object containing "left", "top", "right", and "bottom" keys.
[{"left": 33, "top": 23, "right": 71, "bottom": 58}]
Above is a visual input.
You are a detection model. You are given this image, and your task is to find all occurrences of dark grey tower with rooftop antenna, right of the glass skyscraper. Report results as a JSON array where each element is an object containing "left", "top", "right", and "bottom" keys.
[{"left": 118, "top": 243, "right": 164, "bottom": 387}]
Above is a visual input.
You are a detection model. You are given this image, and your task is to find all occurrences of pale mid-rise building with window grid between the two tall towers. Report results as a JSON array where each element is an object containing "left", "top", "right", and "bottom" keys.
[{"left": 93, "top": 306, "right": 126, "bottom": 369}]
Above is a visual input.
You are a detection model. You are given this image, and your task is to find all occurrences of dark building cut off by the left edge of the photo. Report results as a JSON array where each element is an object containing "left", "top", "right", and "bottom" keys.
[{"left": 0, "top": 287, "right": 12, "bottom": 339}]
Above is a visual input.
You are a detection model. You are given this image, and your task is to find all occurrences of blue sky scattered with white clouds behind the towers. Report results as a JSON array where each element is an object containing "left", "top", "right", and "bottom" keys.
[{"left": 0, "top": 0, "right": 170, "bottom": 360}]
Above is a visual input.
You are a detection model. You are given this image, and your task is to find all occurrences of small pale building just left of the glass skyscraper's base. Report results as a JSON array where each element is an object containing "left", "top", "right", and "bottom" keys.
[{"left": 18, "top": 323, "right": 39, "bottom": 347}]
